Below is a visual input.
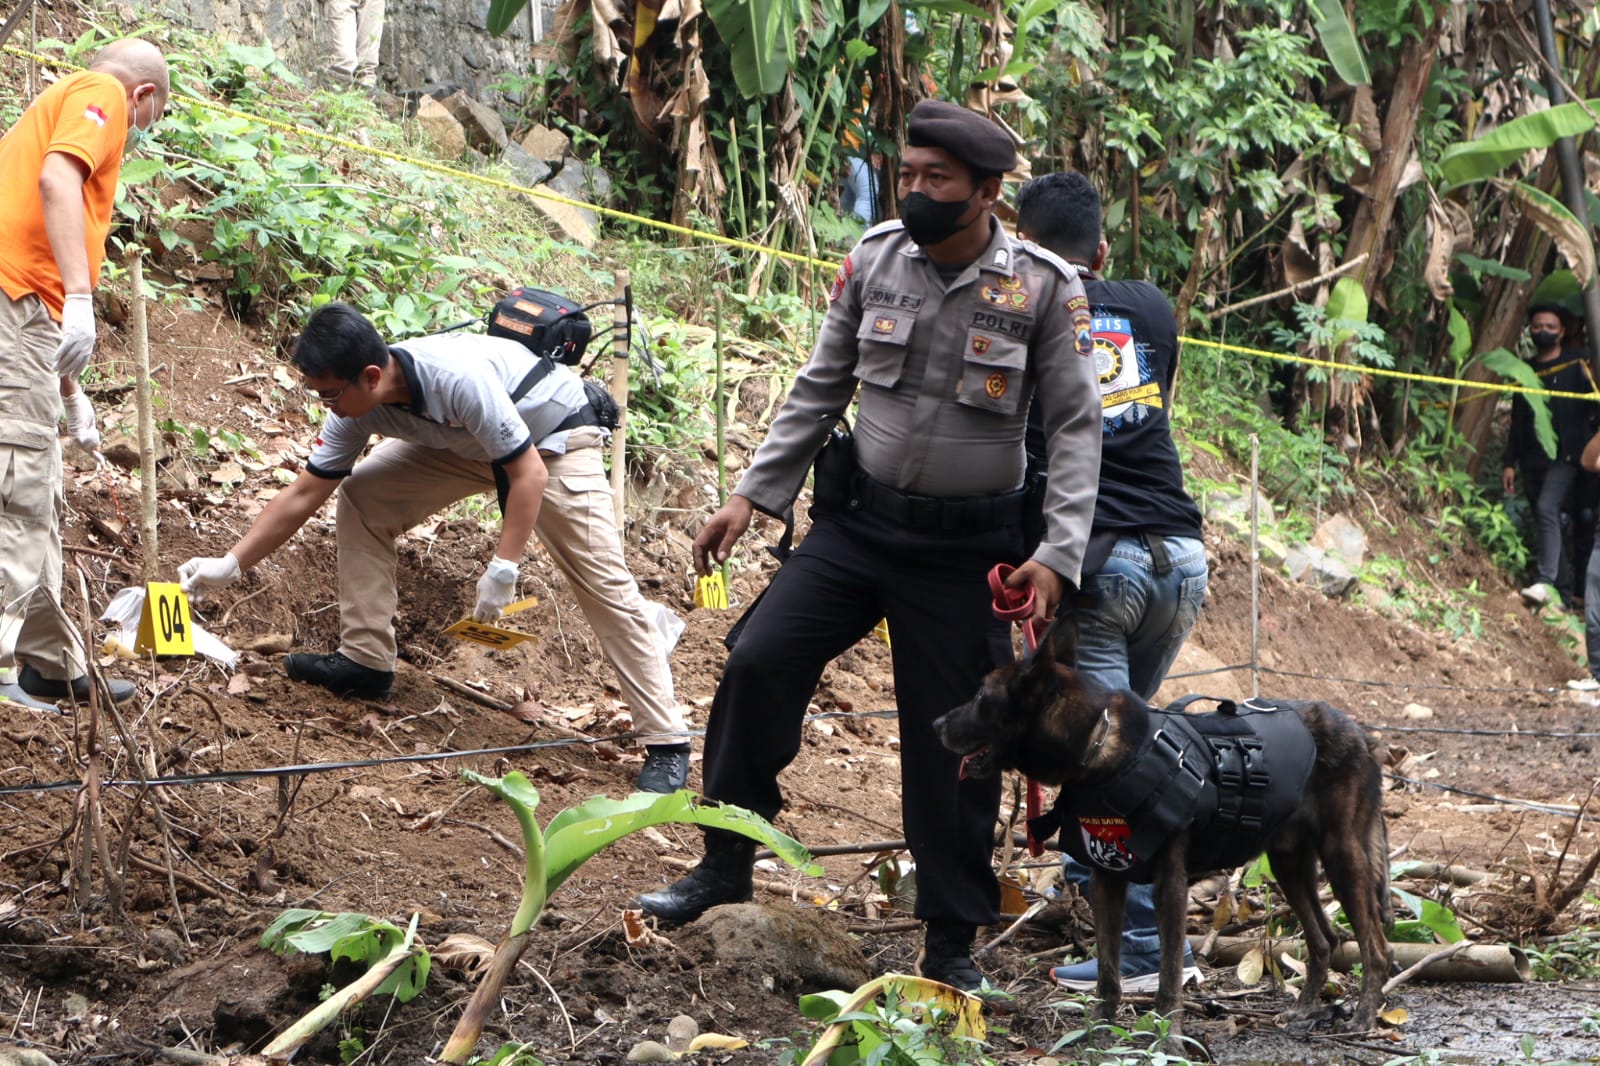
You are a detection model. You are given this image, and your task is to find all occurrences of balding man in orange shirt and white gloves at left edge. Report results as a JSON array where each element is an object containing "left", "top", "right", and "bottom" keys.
[{"left": 0, "top": 38, "right": 170, "bottom": 711}]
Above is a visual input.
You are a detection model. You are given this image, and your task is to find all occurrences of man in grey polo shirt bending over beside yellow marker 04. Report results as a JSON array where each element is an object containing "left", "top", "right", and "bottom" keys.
[{"left": 178, "top": 303, "right": 690, "bottom": 792}]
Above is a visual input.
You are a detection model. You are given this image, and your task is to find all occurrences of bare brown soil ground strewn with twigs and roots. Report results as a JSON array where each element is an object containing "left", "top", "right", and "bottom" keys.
[{"left": 0, "top": 281, "right": 1600, "bottom": 1063}]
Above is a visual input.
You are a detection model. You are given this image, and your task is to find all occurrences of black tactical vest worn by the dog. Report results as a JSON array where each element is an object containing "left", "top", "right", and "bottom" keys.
[{"left": 1029, "top": 696, "right": 1317, "bottom": 884}]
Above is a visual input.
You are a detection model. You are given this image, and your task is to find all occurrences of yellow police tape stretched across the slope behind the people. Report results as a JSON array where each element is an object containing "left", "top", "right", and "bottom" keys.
[{"left": 5, "top": 45, "right": 1600, "bottom": 403}]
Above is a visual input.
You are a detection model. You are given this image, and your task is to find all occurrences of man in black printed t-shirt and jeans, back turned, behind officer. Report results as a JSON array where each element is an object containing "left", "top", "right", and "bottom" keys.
[{"left": 1016, "top": 173, "right": 1206, "bottom": 991}]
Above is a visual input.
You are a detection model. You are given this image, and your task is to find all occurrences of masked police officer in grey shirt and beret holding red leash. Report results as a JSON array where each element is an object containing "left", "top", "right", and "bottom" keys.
[{"left": 638, "top": 101, "right": 1101, "bottom": 989}]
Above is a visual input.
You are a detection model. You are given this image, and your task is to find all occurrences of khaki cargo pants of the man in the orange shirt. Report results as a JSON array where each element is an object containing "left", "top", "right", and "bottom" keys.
[{"left": 0, "top": 291, "right": 85, "bottom": 680}]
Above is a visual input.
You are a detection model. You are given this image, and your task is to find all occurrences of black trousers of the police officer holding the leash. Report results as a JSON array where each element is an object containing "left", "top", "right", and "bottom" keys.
[{"left": 702, "top": 511, "right": 1021, "bottom": 925}]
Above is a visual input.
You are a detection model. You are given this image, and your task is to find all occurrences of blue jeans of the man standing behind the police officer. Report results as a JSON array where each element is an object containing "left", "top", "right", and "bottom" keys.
[{"left": 1062, "top": 536, "right": 1203, "bottom": 956}]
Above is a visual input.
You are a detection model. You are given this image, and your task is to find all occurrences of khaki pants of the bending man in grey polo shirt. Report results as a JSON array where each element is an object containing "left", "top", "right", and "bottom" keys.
[{"left": 336, "top": 427, "right": 688, "bottom": 744}]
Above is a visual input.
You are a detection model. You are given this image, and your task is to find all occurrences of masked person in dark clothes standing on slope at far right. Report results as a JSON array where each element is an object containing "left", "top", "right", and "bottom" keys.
[{"left": 1501, "top": 304, "right": 1594, "bottom": 607}]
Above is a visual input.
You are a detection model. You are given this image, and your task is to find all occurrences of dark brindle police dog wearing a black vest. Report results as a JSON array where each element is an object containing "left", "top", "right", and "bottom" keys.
[{"left": 933, "top": 615, "right": 1389, "bottom": 1032}]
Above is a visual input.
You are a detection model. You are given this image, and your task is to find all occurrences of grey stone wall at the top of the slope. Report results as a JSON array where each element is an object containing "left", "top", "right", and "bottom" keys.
[{"left": 160, "top": 0, "right": 550, "bottom": 110}]
